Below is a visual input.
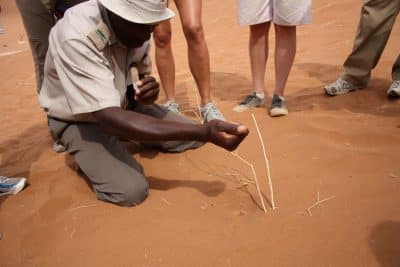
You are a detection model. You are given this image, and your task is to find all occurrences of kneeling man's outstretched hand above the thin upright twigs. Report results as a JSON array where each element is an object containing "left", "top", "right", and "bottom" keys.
[{"left": 206, "top": 120, "right": 249, "bottom": 151}]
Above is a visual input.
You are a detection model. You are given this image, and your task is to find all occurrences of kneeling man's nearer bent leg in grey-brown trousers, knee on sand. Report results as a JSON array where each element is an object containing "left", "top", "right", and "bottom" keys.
[{"left": 49, "top": 118, "right": 148, "bottom": 206}]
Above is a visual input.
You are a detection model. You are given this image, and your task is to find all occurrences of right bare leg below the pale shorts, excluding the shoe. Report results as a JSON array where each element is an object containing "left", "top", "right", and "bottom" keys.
[{"left": 274, "top": 25, "right": 296, "bottom": 96}]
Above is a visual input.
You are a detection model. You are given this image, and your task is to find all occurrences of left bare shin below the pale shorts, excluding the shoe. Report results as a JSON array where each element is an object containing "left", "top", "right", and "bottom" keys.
[{"left": 249, "top": 22, "right": 271, "bottom": 94}]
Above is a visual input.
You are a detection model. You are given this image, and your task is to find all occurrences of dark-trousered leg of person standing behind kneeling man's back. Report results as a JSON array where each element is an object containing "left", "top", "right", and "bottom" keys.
[{"left": 16, "top": 0, "right": 55, "bottom": 92}]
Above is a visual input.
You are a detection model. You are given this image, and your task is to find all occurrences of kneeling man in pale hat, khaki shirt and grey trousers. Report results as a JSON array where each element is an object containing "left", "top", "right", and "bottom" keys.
[{"left": 39, "top": 0, "right": 248, "bottom": 206}]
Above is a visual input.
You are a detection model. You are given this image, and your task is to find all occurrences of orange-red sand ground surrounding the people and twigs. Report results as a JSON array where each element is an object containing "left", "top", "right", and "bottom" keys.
[{"left": 0, "top": 0, "right": 400, "bottom": 266}]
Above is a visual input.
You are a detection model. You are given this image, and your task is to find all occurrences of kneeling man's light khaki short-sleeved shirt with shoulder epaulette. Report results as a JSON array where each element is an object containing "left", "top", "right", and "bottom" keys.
[{"left": 39, "top": 0, "right": 151, "bottom": 121}]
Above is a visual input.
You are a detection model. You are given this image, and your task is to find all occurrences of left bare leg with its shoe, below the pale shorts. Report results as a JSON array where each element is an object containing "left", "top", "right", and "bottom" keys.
[{"left": 233, "top": 22, "right": 271, "bottom": 112}]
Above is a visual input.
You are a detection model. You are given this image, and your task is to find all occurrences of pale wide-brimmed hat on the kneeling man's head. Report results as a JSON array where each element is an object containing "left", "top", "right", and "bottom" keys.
[{"left": 99, "top": 0, "right": 175, "bottom": 24}]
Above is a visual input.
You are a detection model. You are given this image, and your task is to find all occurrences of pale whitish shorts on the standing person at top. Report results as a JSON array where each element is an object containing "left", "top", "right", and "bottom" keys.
[{"left": 238, "top": 0, "right": 312, "bottom": 26}]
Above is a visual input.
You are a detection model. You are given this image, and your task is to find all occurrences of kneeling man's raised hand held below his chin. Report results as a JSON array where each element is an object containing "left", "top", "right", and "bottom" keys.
[{"left": 134, "top": 76, "right": 160, "bottom": 105}]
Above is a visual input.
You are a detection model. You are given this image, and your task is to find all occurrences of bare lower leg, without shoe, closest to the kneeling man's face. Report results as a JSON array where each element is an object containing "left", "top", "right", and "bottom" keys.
[{"left": 153, "top": 20, "right": 175, "bottom": 102}]
